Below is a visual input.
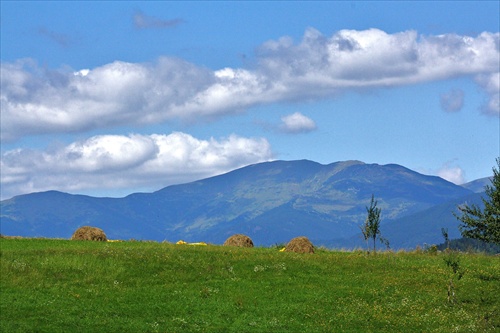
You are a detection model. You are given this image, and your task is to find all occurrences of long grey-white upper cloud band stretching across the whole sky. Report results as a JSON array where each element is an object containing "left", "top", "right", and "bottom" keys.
[{"left": 0, "top": 29, "right": 500, "bottom": 141}]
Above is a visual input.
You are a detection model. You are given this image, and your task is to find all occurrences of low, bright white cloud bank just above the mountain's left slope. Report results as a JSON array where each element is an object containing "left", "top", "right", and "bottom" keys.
[{"left": 0, "top": 132, "right": 273, "bottom": 199}]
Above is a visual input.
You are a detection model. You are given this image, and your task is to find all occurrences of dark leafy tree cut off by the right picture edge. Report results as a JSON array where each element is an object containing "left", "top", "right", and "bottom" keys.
[{"left": 454, "top": 157, "right": 500, "bottom": 244}]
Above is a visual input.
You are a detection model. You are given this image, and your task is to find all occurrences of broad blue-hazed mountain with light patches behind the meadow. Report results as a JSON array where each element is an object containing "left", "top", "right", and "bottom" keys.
[{"left": 0, "top": 160, "right": 473, "bottom": 247}]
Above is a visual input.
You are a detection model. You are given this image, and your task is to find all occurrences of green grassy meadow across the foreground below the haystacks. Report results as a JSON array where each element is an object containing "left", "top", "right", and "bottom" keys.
[{"left": 0, "top": 238, "right": 500, "bottom": 332}]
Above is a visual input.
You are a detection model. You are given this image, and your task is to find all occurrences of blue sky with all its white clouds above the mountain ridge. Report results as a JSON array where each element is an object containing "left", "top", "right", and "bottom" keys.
[{"left": 0, "top": 1, "right": 500, "bottom": 200}]
